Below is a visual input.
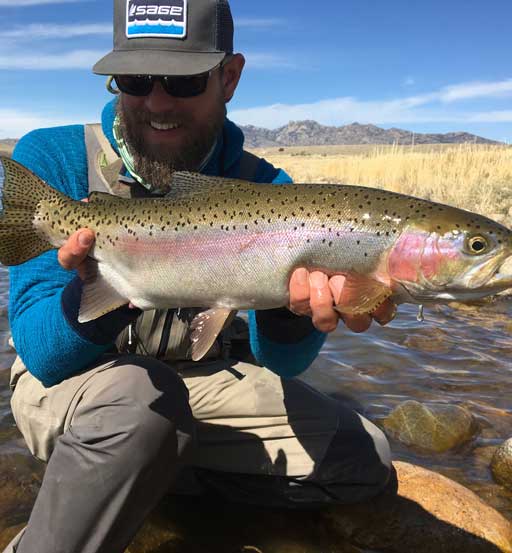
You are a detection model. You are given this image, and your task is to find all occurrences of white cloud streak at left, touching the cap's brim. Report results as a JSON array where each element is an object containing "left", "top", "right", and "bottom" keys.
[{"left": 0, "top": 50, "right": 106, "bottom": 71}]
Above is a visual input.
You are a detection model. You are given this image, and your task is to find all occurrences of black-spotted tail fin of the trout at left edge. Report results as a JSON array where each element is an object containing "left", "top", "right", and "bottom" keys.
[{"left": 0, "top": 156, "right": 62, "bottom": 265}]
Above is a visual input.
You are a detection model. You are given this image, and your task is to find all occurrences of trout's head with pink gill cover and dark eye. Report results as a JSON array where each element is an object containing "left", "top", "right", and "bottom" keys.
[{"left": 387, "top": 208, "right": 512, "bottom": 303}]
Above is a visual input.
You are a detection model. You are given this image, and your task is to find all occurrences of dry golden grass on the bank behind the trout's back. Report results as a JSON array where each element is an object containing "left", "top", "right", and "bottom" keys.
[{"left": 252, "top": 144, "right": 512, "bottom": 221}]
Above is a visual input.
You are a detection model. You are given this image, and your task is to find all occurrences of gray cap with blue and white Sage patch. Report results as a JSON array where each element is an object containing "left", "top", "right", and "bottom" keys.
[{"left": 93, "top": 0, "right": 233, "bottom": 75}]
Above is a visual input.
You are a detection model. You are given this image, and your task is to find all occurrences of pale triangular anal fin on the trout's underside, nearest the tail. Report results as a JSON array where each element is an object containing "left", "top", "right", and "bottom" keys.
[{"left": 78, "top": 257, "right": 129, "bottom": 323}]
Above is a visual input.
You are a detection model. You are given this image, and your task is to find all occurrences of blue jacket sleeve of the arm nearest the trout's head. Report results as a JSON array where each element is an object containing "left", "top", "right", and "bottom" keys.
[{"left": 249, "top": 160, "right": 327, "bottom": 378}]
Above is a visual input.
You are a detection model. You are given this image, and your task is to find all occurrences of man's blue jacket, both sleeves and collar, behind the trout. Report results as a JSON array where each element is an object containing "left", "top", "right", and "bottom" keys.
[{"left": 9, "top": 100, "right": 325, "bottom": 386}]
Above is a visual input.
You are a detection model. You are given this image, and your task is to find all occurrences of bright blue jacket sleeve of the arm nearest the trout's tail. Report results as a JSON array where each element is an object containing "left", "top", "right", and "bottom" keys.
[{"left": 9, "top": 129, "right": 137, "bottom": 386}]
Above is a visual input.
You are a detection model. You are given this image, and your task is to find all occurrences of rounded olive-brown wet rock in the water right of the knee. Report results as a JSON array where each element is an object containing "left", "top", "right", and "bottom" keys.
[{"left": 384, "top": 400, "right": 477, "bottom": 453}]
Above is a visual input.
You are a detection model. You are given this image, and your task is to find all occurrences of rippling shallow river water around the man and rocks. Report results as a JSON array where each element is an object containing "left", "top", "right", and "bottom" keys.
[{"left": 0, "top": 267, "right": 512, "bottom": 550}]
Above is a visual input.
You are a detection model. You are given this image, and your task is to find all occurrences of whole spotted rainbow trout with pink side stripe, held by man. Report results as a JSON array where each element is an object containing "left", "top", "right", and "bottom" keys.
[{"left": 0, "top": 158, "right": 512, "bottom": 360}]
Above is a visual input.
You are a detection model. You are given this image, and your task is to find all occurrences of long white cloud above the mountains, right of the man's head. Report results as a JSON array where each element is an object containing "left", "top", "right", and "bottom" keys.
[{"left": 230, "top": 80, "right": 512, "bottom": 128}]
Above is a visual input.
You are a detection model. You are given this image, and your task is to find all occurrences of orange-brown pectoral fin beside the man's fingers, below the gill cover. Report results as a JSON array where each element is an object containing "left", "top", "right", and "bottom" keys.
[{"left": 334, "top": 273, "right": 393, "bottom": 315}]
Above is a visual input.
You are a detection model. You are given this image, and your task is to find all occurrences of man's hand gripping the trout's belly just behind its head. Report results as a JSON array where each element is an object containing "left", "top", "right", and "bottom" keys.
[{"left": 289, "top": 269, "right": 396, "bottom": 332}]
